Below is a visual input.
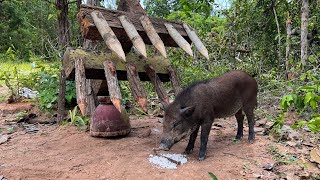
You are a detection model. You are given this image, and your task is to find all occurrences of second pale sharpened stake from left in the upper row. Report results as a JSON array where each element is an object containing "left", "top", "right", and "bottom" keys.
[{"left": 119, "top": 15, "right": 147, "bottom": 58}]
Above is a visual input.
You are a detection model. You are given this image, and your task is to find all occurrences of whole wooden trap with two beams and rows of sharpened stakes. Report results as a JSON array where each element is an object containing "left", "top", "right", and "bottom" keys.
[{"left": 63, "top": 0, "right": 209, "bottom": 116}]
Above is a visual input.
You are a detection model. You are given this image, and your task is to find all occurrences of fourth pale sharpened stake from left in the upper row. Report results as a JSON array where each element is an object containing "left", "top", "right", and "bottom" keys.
[{"left": 164, "top": 23, "right": 193, "bottom": 56}]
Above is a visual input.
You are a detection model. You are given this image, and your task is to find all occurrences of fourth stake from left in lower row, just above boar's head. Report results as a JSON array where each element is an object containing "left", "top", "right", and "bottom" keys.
[{"left": 145, "top": 64, "right": 169, "bottom": 105}]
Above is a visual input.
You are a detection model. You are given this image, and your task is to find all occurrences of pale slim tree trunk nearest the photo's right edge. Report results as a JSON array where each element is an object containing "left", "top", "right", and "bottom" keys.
[{"left": 301, "top": 0, "right": 309, "bottom": 66}]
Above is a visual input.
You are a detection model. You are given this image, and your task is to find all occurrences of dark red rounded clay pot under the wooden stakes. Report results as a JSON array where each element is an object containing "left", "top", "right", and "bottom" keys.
[{"left": 90, "top": 96, "right": 131, "bottom": 137}]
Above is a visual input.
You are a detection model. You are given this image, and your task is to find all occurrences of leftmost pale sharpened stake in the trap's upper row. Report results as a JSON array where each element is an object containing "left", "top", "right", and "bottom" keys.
[{"left": 91, "top": 11, "right": 126, "bottom": 61}]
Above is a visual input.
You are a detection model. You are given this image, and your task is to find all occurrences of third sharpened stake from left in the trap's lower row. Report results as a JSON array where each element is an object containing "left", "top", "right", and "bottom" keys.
[{"left": 126, "top": 63, "right": 148, "bottom": 112}]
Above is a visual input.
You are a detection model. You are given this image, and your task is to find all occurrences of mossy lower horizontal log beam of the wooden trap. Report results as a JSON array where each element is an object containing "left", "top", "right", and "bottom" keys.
[{"left": 64, "top": 48, "right": 170, "bottom": 82}]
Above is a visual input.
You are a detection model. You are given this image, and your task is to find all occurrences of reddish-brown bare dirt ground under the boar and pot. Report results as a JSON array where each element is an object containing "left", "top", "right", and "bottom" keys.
[{"left": 0, "top": 102, "right": 318, "bottom": 180}]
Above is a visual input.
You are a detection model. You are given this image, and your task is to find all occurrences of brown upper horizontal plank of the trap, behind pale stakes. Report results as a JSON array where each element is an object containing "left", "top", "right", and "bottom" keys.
[{"left": 78, "top": 5, "right": 191, "bottom": 47}]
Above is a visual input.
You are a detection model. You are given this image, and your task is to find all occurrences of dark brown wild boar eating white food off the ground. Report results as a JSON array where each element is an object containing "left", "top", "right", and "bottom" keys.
[{"left": 159, "top": 71, "right": 258, "bottom": 160}]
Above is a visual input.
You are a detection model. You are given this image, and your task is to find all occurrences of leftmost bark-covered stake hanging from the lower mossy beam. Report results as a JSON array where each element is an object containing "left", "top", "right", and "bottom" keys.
[{"left": 75, "top": 58, "right": 87, "bottom": 116}]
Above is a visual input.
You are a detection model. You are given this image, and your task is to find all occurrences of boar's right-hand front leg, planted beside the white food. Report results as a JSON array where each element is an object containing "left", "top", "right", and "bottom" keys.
[{"left": 199, "top": 119, "right": 213, "bottom": 161}]
